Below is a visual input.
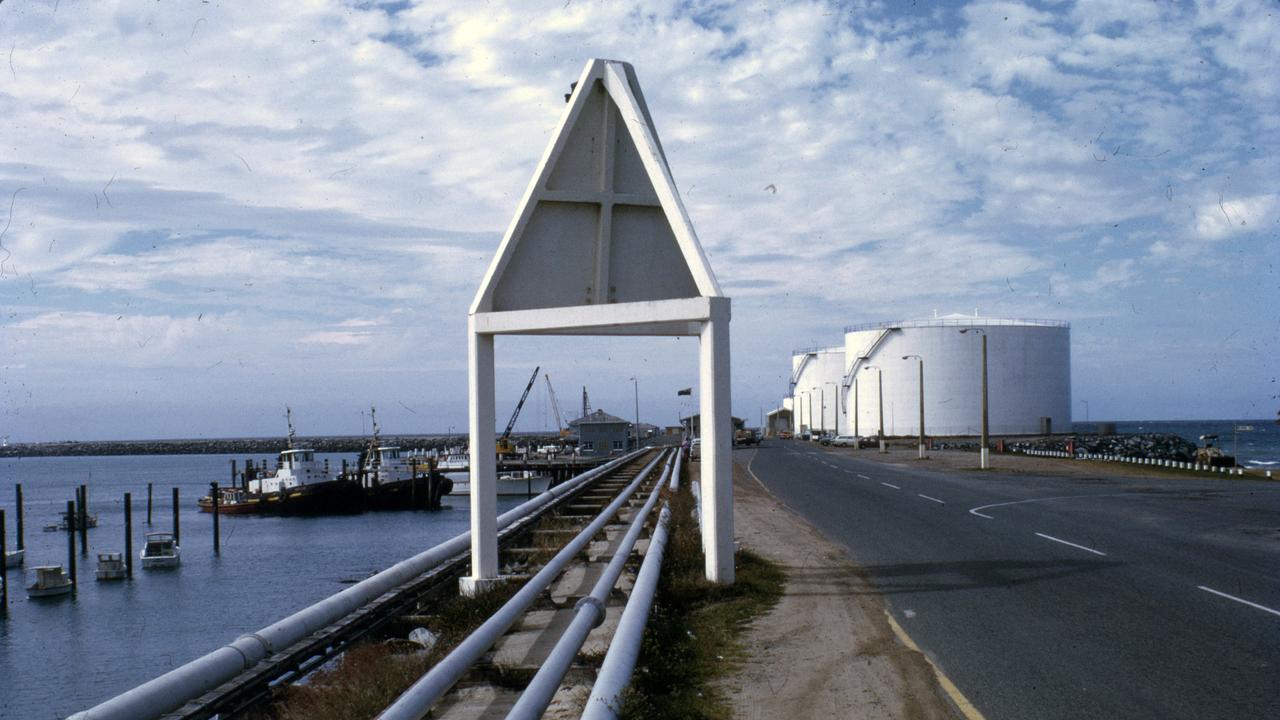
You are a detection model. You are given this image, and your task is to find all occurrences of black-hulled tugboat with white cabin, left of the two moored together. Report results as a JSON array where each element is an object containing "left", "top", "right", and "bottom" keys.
[{"left": 198, "top": 406, "right": 365, "bottom": 515}]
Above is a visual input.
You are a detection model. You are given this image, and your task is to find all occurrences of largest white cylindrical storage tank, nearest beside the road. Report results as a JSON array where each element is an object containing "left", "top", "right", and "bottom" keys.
[{"left": 844, "top": 315, "right": 1071, "bottom": 437}]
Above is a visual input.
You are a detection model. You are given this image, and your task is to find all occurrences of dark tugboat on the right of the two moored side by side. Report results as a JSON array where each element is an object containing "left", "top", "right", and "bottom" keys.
[{"left": 357, "top": 407, "right": 453, "bottom": 510}]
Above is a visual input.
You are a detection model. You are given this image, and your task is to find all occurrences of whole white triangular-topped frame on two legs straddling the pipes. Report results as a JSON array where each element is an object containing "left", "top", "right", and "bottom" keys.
[{"left": 463, "top": 60, "right": 733, "bottom": 592}]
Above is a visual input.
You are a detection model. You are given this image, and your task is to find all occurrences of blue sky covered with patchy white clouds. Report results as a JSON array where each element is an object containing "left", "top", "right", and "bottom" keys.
[{"left": 0, "top": 0, "right": 1280, "bottom": 442}]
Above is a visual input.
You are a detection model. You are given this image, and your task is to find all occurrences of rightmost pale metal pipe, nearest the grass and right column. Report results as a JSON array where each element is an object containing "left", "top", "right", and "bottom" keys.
[{"left": 582, "top": 503, "right": 671, "bottom": 720}]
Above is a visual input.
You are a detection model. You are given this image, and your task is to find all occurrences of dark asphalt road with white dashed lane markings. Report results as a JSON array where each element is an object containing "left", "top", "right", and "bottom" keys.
[{"left": 735, "top": 441, "right": 1280, "bottom": 720}]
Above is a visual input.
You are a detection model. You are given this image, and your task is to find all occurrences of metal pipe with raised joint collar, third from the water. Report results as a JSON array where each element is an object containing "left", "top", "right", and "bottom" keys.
[{"left": 507, "top": 457, "right": 673, "bottom": 720}]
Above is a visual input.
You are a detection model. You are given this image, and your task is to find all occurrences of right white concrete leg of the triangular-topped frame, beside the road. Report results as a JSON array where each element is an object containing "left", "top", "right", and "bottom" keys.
[{"left": 698, "top": 299, "right": 733, "bottom": 584}]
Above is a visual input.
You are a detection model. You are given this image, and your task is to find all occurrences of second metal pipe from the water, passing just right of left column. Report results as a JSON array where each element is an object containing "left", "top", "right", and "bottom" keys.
[{"left": 378, "top": 455, "right": 662, "bottom": 720}]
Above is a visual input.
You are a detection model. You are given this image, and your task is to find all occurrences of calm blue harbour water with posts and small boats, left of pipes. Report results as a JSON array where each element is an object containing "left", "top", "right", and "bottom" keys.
[{"left": 0, "top": 455, "right": 520, "bottom": 720}]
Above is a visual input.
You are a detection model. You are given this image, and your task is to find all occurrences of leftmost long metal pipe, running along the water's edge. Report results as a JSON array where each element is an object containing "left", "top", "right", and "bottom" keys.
[{"left": 68, "top": 452, "right": 641, "bottom": 720}]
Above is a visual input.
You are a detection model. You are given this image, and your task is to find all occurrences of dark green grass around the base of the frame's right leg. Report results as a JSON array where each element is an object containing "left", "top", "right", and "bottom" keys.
[{"left": 621, "top": 484, "right": 786, "bottom": 720}]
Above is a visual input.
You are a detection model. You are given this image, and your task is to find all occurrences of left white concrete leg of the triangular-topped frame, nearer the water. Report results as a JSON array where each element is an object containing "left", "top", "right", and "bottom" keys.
[{"left": 461, "top": 316, "right": 498, "bottom": 596}]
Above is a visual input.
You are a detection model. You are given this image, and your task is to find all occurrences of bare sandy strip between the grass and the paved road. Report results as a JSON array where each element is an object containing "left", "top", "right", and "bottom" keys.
[{"left": 722, "top": 457, "right": 959, "bottom": 720}]
